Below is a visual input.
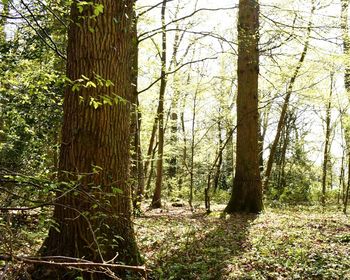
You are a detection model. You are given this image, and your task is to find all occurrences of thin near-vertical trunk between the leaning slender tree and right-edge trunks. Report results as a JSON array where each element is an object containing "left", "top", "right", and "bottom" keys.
[{"left": 321, "top": 73, "right": 334, "bottom": 206}]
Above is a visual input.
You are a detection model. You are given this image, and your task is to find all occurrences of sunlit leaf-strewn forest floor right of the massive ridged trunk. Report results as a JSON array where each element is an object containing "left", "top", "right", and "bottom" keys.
[{"left": 135, "top": 205, "right": 350, "bottom": 280}]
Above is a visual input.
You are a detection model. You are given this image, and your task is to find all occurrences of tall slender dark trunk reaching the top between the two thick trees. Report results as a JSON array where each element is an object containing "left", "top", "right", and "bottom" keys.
[{"left": 151, "top": 0, "right": 167, "bottom": 208}]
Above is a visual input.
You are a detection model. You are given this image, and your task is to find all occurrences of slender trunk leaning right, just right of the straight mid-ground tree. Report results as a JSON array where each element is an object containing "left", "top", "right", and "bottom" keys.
[{"left": 263, "top": 3, "right": 315, "bottom": 191}]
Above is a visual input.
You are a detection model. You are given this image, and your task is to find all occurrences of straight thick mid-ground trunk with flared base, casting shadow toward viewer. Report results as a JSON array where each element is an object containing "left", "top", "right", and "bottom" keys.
[{"left": 225, "top": 0, "right": 263, "bottom": 213}]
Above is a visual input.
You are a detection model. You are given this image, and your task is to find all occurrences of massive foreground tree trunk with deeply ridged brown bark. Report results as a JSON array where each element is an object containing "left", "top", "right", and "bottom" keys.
[{"left": 33, "top": 0, "right": 140, "bottom": 279}]
